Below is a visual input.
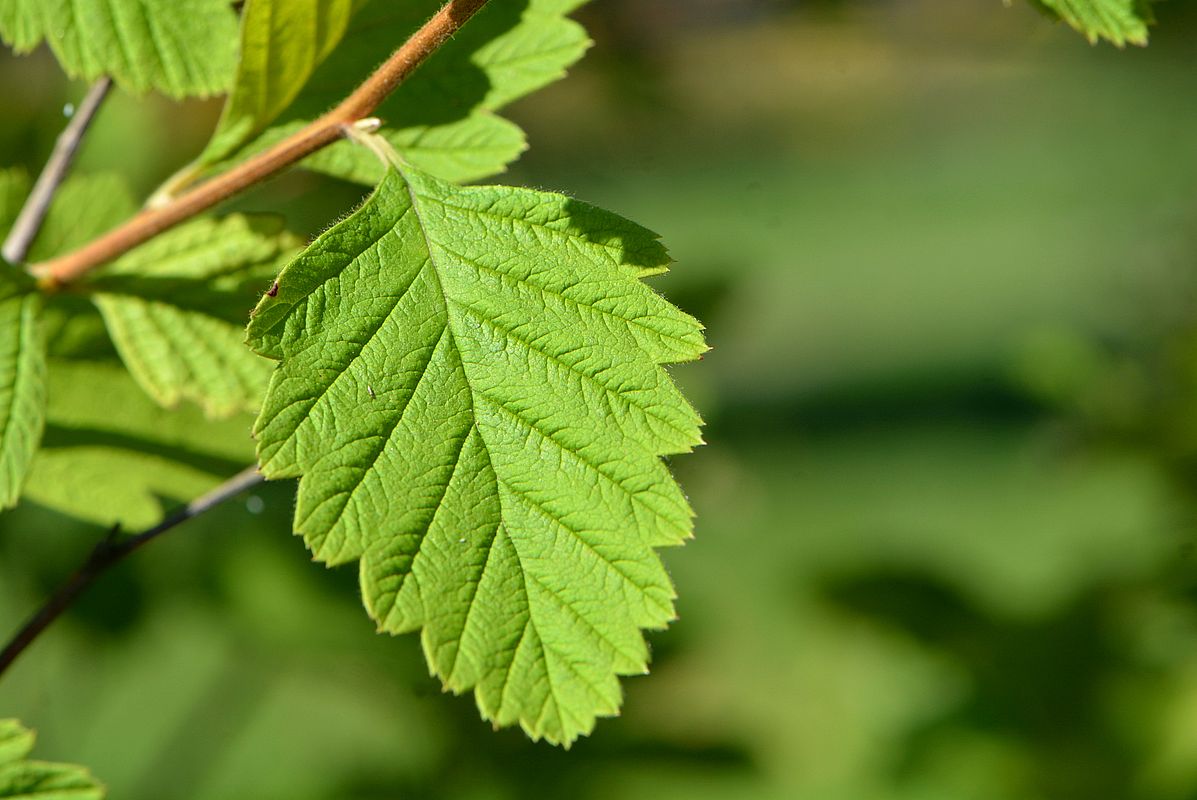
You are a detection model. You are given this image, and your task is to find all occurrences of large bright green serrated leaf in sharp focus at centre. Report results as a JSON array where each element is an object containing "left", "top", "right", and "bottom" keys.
[{"left": 249, "top": 170, "right": 705, "bottom": 744}]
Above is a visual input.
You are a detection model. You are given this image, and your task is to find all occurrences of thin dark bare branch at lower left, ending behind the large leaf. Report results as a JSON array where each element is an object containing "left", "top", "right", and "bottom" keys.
[{"left": 0, "top": 466, "right": 262, "bottom": 675}]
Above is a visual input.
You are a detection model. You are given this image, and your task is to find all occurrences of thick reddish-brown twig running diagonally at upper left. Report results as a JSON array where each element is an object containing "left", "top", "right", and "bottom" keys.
[{"left": 32, "top": 0, "right": 487, "bottom": 289}]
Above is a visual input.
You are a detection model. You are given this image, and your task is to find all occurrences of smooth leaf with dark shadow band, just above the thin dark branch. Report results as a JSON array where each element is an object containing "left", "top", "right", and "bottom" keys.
[{"left": 24, "top": 359, "right": 254, "bottom": 531}]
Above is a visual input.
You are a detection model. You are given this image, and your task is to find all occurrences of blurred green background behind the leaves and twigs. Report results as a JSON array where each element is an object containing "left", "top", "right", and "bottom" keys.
[{"left": 11, "top": 0, "right": 1197, "bottom": 800}]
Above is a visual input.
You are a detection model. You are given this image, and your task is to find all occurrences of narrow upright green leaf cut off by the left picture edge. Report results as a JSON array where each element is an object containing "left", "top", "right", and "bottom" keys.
[{"left": 0, "top": 277, "right": 45, "bottom": 509}]
